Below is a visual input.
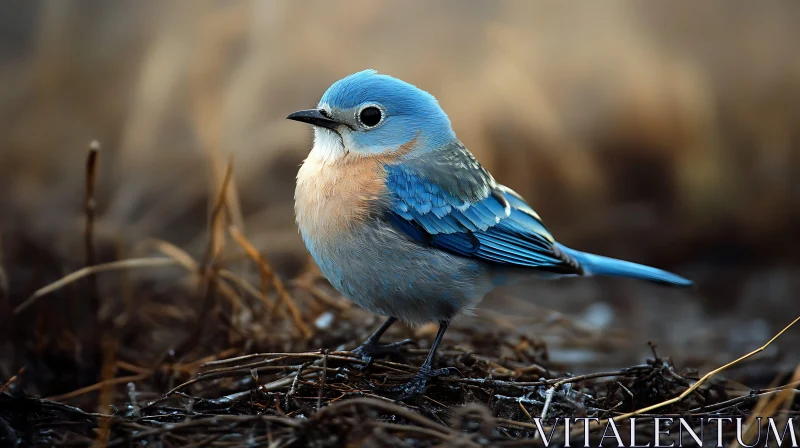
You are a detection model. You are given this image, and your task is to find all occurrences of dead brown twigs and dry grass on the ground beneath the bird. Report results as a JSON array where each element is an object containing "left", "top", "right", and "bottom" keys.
[{"left": 0, "top": 152, "right": 800, "bottom": 446}]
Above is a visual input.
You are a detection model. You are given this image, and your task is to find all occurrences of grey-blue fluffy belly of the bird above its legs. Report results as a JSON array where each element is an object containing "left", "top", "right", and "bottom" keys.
[{"left": 301, "top": 221, "right": 492, "bottom": 325}]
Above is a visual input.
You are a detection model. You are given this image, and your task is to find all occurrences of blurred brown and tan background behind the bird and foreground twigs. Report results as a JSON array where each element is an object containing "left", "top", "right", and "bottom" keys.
[{"left": 0, "top": 0, "right": 800, "bottom": 395}]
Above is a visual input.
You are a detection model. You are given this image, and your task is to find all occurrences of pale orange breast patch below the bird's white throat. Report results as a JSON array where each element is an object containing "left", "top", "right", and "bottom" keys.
[{"left": 295, "top": 154, "right": 387, "bottom": 239}]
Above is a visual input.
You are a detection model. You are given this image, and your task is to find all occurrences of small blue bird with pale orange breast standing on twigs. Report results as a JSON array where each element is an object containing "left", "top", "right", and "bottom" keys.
[{"left": 286, "top": 69, "right": 694, "bottom": 398}]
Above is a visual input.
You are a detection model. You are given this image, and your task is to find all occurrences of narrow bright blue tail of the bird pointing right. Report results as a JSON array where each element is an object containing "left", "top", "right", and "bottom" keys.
[{"left": 559, "top": 244, "right": 694, "bottom": 287}]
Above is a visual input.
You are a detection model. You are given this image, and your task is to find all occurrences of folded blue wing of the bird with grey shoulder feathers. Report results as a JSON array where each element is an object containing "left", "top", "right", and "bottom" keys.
[{"left": 386, "top": 142, "right": 581, "bottom": 274}]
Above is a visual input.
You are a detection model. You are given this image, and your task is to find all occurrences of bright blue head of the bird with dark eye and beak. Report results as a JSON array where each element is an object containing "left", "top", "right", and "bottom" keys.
[{"left": 287, "top": 70, "right": 455, "bottom": 159}]
